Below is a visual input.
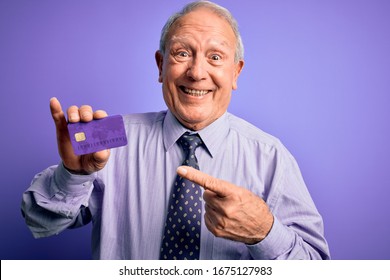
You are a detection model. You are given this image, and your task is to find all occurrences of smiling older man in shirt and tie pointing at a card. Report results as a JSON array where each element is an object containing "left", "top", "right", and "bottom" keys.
[{"left": 22, "top": 1, "right": 329, "bottom": 259}]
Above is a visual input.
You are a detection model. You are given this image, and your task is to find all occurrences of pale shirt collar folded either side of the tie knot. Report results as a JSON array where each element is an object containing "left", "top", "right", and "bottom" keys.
[{"left": 163, "top": 110, "right": 229, "bottom": 157}]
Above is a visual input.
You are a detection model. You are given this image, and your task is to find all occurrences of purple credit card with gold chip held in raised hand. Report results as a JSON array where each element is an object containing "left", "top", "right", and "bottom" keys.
[{"left": 68, "top": 115, "right": 127, "bottom": 155}]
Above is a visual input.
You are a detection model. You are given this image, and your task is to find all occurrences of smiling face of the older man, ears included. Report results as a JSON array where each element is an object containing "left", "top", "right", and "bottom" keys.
[{"left": 156, "top": 8, "right": 244, "bottom": 130}]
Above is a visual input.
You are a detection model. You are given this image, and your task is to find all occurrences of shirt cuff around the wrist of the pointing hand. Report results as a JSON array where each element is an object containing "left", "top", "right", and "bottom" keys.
[{"left": 247, "top": 217, "right": 294, "bottom": 260}]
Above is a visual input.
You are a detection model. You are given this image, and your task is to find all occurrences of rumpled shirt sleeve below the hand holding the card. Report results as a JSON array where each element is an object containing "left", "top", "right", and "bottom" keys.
[{"left": 21, "top": 163, "right": 96, "bottom": 238}]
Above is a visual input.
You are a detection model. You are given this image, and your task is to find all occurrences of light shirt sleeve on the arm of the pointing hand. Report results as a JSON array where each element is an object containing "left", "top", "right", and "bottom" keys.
[{"left": 248, "top": 144, "right": 330, "bottom": 260}]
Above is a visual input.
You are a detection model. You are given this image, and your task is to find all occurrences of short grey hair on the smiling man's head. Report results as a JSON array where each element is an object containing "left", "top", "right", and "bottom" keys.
[{"left": 160, "top": 1, "right": 244, "bottom": 63}]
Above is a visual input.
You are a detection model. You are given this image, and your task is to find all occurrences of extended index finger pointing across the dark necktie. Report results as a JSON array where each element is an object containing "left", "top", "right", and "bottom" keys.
[{"left": 177, "top": 165, "right": 234, "bottom": 197}]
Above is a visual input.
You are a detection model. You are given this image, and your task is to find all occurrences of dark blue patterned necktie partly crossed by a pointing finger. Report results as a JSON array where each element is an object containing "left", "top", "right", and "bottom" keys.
[{"left": 160, "top": 132, "right": 203, "bottom": 260}]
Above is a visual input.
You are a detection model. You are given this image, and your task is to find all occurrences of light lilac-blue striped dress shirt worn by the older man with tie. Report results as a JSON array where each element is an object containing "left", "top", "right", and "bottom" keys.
[{"left": 22, "top": 111, "right": 330, "bottom": 260}]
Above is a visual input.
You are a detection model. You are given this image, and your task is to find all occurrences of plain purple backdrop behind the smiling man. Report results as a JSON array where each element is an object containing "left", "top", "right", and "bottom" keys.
[{"left": 0, "top": 0, "right": 390, "bottom": 259}]
